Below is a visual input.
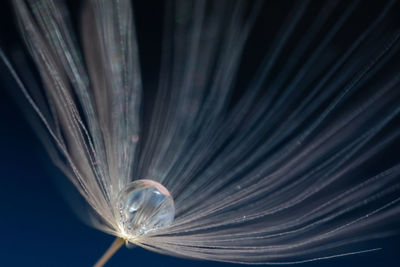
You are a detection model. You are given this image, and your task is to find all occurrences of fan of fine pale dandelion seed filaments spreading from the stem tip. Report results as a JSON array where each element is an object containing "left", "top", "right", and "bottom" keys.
[{"left": 0, "top": 0, "right": 400, "bottom": 264}]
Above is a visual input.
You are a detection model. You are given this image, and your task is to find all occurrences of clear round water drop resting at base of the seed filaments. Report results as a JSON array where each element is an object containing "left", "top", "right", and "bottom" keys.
[{"left": 117, "top": 180, "right": 175, "bottom": 236}]
